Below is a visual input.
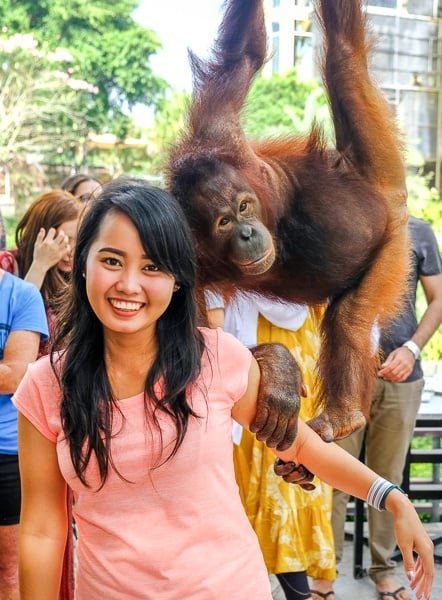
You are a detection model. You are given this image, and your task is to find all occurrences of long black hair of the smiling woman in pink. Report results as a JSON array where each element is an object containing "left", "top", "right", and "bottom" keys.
[{"left": 51, "top": 179, "right": 204, "bottom": 485}]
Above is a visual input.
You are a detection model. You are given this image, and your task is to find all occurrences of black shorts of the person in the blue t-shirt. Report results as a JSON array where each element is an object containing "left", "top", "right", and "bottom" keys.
[{"left": 0, "top": 454, "right": 21, "bottom": 526}]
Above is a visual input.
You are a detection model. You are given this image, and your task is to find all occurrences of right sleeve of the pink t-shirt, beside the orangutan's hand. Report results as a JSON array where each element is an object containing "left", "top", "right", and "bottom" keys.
[{"left": 214, "top": 329, "right": 252, "bottom": 403}]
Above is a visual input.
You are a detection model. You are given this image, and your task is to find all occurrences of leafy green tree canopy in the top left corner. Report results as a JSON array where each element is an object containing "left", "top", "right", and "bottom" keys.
[{"left": 0, "top": 0, "right": 166, "bottom": 137}]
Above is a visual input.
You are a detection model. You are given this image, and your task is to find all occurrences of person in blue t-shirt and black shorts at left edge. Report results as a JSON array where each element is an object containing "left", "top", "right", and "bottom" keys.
[{"left": 0, "top": 269, "right": 48, "bottom": 598}]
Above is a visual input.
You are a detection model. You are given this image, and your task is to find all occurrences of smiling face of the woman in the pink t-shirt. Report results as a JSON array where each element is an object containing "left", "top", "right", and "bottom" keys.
[{"left": 86, "top": 212, "right": 175, "bottom": 342}]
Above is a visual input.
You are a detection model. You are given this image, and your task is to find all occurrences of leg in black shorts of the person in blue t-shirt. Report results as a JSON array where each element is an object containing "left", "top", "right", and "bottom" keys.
[{"left": 0, "top": 454, "right": 21, "bottom": 600}]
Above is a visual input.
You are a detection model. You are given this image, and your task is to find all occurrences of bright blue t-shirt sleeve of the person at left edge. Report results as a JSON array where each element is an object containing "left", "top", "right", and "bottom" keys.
[{"left": 11, "top": 284, "right": 48, "bottom": 339}]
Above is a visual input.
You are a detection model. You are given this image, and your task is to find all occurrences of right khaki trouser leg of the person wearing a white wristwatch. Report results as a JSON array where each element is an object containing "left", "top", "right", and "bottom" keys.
[{"left": 365, "top": 380, "right": 423, "bottom": 600}]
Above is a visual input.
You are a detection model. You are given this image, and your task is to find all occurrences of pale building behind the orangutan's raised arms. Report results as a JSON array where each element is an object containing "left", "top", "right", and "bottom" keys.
[{"left": 264, "top": 0, "right": 442, "bottom": 191}]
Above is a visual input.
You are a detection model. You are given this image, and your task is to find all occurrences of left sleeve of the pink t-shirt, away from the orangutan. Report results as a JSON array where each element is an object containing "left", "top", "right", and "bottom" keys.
[{"left": 12, "top": 356, "right": 61, "bottom": 442}]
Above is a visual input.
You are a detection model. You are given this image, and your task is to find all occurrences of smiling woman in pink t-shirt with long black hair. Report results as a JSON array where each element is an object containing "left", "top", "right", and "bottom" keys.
[{"left": 14, "top": 179, "right": 433, "bottom": 600}]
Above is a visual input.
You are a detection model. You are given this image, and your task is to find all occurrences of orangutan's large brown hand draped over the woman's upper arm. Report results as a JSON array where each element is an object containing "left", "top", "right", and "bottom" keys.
[{"left": 250, "top": 344, "right": 302, "bottom": 450}]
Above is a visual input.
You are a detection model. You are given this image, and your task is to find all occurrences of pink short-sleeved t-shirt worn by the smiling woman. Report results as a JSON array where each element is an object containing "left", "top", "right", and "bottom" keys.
[{"left": 14, "top": 329, "right": 272, "bottom": 600}]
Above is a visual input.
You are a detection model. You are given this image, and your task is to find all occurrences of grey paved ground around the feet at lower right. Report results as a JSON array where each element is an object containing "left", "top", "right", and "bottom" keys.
[{"left": 271, "top": 524, "right": 442, "bottom": 600}]
